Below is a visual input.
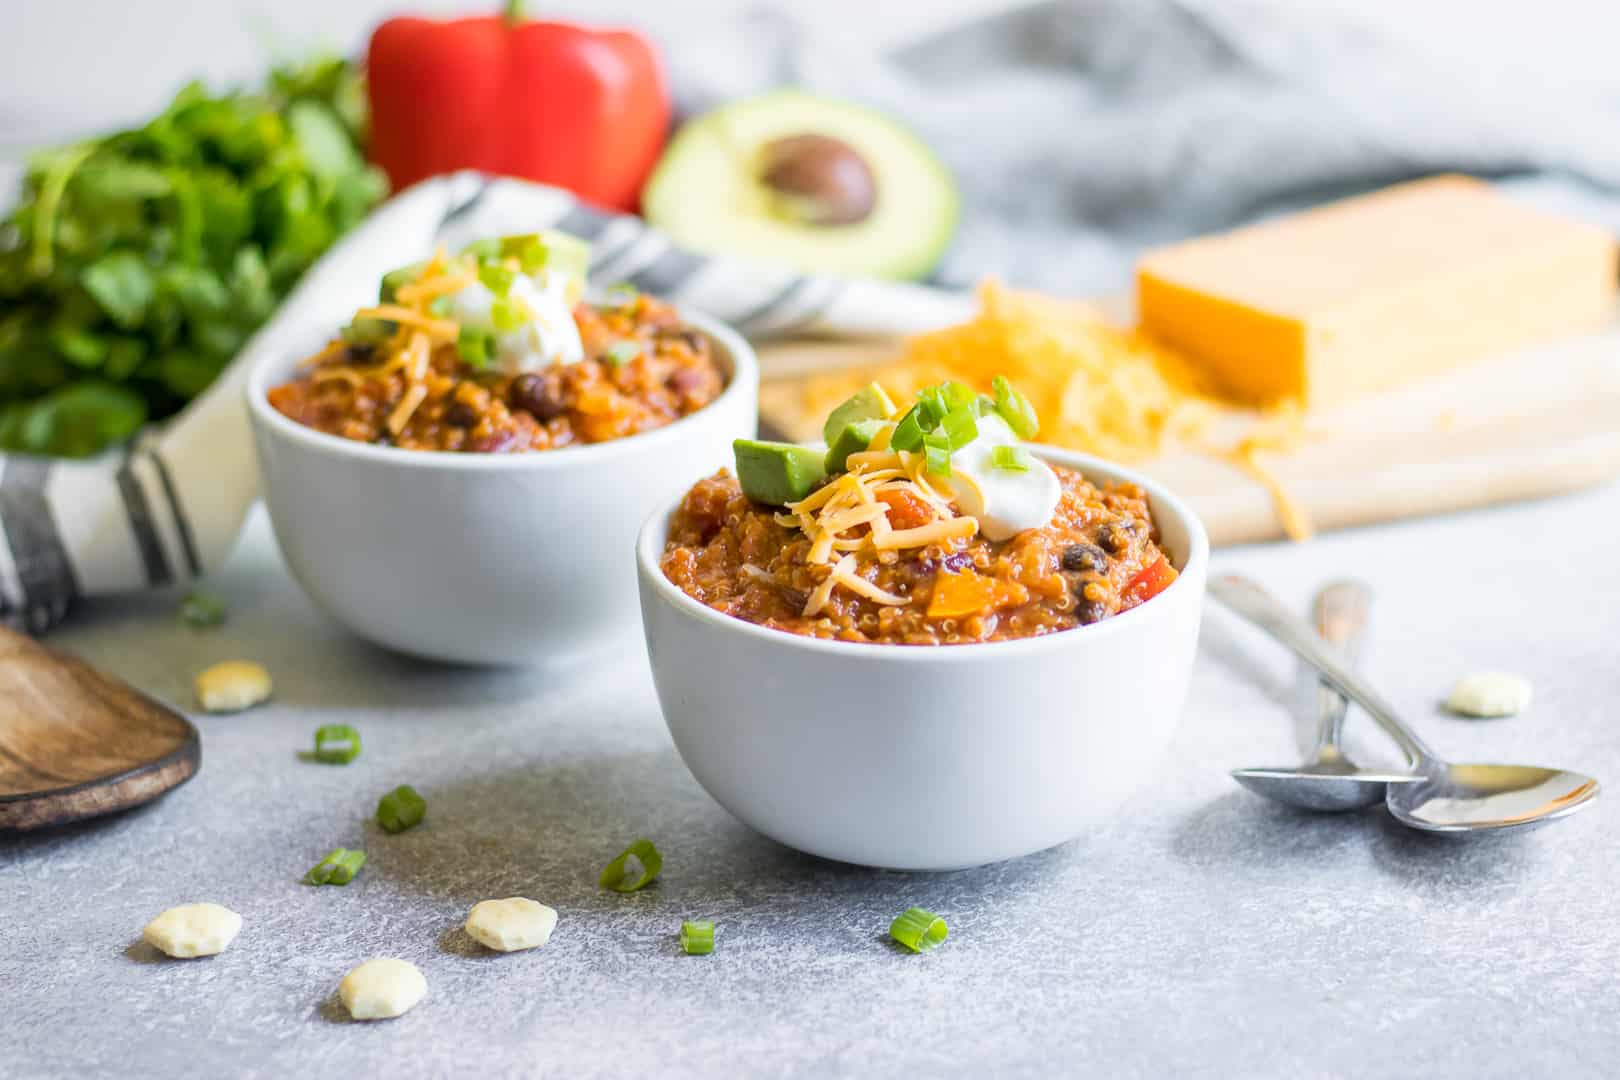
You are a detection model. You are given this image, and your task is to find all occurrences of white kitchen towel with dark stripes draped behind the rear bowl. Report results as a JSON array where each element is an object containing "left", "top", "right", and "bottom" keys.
[{"left": 0, "top": 173, "right": 970, "bottom": 633}]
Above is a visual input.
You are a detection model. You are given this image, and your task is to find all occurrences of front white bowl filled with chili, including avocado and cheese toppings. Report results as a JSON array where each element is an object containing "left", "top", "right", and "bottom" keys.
[{"left": 637, "top": 381, "right": 1209, "bottom": 870}]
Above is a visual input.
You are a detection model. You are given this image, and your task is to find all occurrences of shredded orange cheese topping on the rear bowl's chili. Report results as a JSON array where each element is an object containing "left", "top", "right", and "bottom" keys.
[{"left": 305, "top": 248, "right": 476, "bottom": 436}]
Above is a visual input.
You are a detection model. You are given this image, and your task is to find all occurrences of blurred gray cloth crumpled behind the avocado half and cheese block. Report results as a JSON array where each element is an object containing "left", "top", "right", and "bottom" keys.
[{"left": 671, "top": 0, "right": 1620, "bottom": 295}]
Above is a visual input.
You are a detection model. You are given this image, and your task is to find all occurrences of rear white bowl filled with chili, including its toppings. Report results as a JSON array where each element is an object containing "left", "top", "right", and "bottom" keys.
[{"left": 246, "top": 233, "right": 758, "bottom": 664}]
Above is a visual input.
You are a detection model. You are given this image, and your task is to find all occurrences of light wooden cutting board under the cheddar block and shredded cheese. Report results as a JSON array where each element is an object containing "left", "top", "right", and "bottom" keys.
[{"left": 760, "top": 318, "right": 1620, "bottom": 544}]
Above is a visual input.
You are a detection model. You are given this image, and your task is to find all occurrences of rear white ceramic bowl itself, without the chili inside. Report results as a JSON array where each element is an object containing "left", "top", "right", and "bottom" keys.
[{"left": 248, "top": 311, "right": 760, "bottom": 664}]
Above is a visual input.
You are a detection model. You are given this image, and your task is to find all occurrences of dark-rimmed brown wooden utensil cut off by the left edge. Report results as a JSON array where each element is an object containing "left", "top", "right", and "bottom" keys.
[{"left": 0, "top": 627, "right": 203, "bottom": 832}]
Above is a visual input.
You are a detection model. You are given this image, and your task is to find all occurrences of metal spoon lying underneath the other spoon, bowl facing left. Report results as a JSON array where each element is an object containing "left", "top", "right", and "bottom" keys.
[{"left": 1231, "top": 581, "right": 1421, "bottom": 811}]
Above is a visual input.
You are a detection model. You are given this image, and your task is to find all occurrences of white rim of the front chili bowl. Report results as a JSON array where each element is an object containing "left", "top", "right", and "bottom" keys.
[{"left": 635, "top": 445, "right": 1210, "bottom": 664}]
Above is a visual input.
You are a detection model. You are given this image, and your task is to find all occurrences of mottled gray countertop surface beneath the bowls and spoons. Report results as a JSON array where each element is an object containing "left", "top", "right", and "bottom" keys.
[{"left": 0, "top": 487, "right": 1620, "bottom": 1077}]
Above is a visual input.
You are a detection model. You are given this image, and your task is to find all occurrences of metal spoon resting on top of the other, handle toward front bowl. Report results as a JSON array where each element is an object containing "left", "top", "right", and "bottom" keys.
[{"left": 1209, "top": 575, "right": 1597, "bottom": 832}]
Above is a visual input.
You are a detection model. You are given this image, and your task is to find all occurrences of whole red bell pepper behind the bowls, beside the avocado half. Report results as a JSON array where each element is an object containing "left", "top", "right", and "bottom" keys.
[{"left": 366, "top": 2, "right": 669, "bottom": 210}]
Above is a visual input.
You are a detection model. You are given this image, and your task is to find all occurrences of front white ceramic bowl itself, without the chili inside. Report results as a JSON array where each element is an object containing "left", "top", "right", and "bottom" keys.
[{"left": 637, "top": 449, "right": 1209, "bottom": 870}]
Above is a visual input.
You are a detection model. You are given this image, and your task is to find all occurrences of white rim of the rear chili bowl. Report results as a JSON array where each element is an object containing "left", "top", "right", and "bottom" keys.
[{"left": 246, "top": 304, "right": 760, "bottom": 471}]
